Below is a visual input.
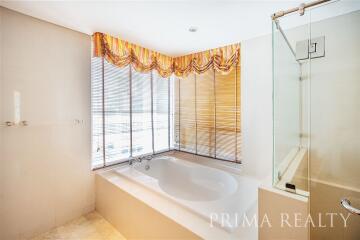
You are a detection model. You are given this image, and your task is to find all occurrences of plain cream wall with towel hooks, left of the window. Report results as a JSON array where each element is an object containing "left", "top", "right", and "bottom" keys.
[{"left": 0, "top": 8, "right": 94, "bottom": 240}]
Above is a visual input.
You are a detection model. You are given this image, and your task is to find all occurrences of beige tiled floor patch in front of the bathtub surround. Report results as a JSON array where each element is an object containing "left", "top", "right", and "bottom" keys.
[{"left": 32, "top": 212, "right": 125, "bottom": 240}]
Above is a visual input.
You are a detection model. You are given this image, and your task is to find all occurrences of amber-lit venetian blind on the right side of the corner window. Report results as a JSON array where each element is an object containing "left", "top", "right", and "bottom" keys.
[{"left": 175, "top": 67, "right": 241, "bottom": 162}]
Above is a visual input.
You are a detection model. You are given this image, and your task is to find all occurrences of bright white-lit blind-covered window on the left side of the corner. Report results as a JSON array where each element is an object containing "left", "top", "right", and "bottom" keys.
[{"left": 91, "top": 58, "right": 173, "bottom": 168}]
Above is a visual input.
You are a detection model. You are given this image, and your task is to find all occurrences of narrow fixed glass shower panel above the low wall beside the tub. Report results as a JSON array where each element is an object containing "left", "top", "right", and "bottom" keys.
[{"left": 272, "top": 10, "right": 310, "bottom": 196}]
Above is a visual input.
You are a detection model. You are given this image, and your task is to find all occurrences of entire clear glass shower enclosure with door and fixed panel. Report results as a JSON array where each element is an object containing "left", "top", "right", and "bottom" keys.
[{"left": 272, "top": 1, "right": 360, "bottom": 240}]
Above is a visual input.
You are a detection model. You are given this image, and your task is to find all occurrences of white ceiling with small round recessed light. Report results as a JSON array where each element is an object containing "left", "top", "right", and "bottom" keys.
[{"left": 0, "top": 0, "right": 360, "bottom": 56}]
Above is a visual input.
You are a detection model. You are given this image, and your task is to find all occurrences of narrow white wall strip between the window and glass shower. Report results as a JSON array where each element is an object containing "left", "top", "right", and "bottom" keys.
[{"left": 241, "top": 34, "right": 272, "bottom": 179}]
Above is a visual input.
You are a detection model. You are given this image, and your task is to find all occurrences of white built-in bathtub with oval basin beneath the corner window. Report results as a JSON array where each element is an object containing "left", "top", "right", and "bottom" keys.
[{"left": 112, "top": 151, "right": 259, "bottom": 232}]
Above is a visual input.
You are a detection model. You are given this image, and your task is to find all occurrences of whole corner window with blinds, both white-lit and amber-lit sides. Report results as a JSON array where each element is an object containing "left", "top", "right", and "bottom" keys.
[{"left": 91, "top": 58, "right": 241, "bottom": 168}]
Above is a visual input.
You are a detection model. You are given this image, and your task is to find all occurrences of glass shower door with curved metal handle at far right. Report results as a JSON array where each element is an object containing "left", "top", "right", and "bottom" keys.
[{"left": 309, "top": 1, "right": 360, "bottom": 240}]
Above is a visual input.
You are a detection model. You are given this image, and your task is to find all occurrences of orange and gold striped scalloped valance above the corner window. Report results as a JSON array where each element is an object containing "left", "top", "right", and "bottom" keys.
[{"left": 93, "top": 32, "right": 240, "bottom": 77}]
